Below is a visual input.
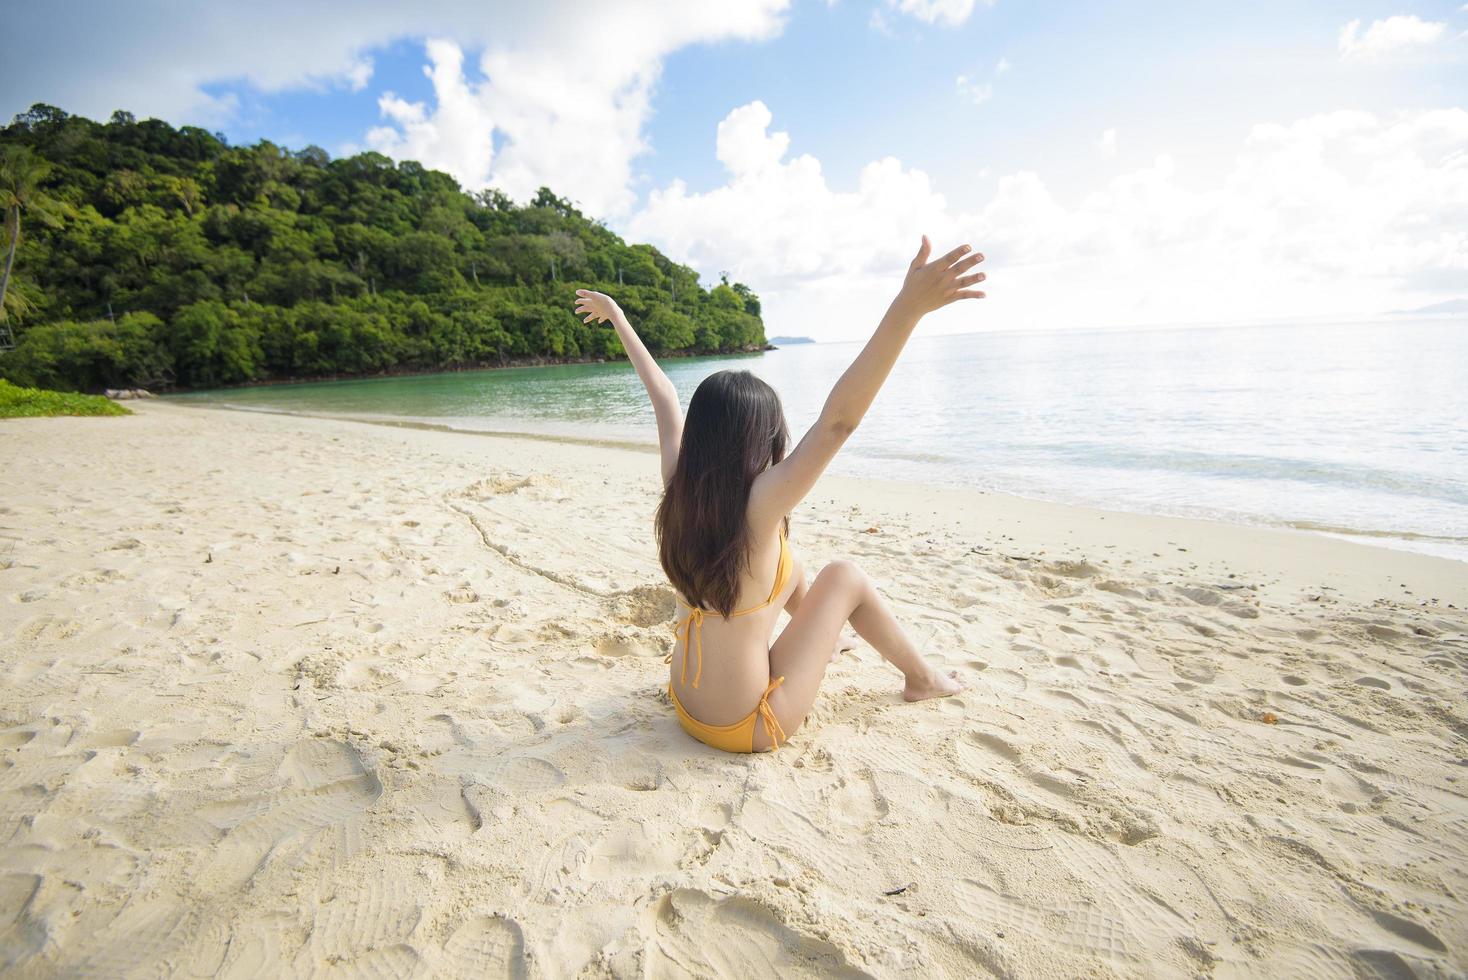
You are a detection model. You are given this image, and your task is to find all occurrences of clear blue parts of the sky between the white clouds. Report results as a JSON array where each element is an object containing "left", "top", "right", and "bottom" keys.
[{"left": 186, "top": 0, "right": 1468, "bottom": 205}]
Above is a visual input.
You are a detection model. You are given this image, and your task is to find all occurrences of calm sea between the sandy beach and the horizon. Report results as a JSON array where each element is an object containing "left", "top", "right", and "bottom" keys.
[{"left": 168, "top": 318, "right": 1468, "bottom": 560}]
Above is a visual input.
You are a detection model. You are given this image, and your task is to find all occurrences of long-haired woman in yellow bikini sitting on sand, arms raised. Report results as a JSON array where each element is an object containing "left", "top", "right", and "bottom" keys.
[{"left": 575, "top": 235, "right": 985, "bottom": 753}]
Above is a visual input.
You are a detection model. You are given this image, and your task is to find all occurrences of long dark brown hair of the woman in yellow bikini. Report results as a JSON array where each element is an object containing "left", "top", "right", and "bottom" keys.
[{"left": 656, "top": 371, "right": 790, "bottom": 616}]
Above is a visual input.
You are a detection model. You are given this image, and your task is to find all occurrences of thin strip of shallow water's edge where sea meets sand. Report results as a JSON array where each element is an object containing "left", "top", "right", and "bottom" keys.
[{"left": 160, "top": 401, "right": 1468, "bottom": 578}]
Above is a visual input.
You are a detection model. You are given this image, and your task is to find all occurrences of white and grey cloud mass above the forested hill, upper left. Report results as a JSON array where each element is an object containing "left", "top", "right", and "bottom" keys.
[{"left": 0, "top": 0, "right": 788, "bottom": 216}]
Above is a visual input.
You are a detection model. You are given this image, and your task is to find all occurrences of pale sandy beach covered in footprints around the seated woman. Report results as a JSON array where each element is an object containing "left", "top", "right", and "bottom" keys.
[{"left": 0, "top": 402, "right": 1468, "bottom": 977}]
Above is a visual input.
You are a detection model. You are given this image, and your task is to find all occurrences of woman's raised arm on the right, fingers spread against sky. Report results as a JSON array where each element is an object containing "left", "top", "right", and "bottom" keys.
[{"left": 749, "top": 235, "right": 985, "bottom": 533}]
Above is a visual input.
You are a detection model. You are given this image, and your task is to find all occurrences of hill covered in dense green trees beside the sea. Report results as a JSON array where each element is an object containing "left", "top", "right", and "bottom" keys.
[{"left": 0, "top": 106, "right": 765, "bottom": 390}]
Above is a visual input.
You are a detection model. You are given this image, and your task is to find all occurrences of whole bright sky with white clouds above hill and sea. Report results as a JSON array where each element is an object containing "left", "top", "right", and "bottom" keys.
[{"left": 0, "top": 0, "right": 1468, "bottom": 340}]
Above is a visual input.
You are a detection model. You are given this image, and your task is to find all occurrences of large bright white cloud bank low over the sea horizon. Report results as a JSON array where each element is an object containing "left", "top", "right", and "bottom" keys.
[{"left": 625, "top": 103, "right": 1468, "bottom": 339}]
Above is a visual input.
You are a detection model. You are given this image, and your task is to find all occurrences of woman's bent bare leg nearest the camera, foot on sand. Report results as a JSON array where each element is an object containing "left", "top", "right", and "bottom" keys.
[{"left": 755, "top": 560, "right": 963, "bottom": 748}]
